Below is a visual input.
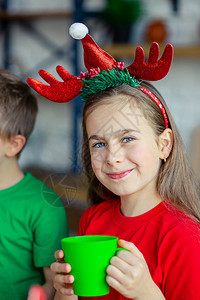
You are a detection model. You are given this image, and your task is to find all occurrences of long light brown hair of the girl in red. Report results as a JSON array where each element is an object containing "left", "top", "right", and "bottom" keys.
[{"left": 82, "top": 82, "right": 200, "bottom": 223}]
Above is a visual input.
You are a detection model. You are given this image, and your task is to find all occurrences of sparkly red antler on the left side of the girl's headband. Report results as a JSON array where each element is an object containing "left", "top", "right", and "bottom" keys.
[{"left": 27, "top": 66, "right": 83, "bottom": 102}]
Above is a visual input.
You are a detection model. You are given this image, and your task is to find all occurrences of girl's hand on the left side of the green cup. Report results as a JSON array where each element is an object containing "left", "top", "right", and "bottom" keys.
[{"left": 50, "top": 250, "right": 74, "bottom": 296}]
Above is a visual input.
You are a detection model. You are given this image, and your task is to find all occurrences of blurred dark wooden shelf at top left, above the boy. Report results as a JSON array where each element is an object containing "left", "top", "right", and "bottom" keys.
[{"left": 0, "top": 11, "right": 72, "bottom": 20}]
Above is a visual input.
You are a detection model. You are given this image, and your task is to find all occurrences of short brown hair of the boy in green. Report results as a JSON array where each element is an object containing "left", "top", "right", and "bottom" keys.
[{"left": 0, "top": 69, "right": 38, "bottom": 141}]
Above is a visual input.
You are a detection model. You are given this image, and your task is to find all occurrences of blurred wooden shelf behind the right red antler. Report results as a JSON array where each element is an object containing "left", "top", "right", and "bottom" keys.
[{"left": 102, "top": 44, "right": 200, "bottom": 59}]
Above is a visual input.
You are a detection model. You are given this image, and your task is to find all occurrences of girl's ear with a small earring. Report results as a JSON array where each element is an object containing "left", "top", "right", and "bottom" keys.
[{"left": 158, "top": 128, "right": 174, "bottom": 159}]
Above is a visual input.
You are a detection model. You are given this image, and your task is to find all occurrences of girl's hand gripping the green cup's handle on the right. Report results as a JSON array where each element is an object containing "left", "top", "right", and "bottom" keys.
[{"left": 106, "top": 240, "right": 165, "bottom": 300}]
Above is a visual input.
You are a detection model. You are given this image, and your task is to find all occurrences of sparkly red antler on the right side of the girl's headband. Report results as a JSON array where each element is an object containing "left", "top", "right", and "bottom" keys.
[{"left": 127, "top": 42, "right": 173, "bottom": 81}]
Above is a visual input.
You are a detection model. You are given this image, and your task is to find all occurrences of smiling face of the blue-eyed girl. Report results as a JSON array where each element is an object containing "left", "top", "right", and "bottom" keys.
[{"left": 86, "top": 96, "right": 164, "bottom": 205}]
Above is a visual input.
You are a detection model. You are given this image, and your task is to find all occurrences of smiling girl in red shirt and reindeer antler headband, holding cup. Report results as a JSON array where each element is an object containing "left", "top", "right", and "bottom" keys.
[{"left": 28, "top": 22, "right": 200, "bottom": 300}]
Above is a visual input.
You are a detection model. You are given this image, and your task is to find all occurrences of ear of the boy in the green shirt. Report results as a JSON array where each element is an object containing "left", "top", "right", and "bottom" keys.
[{"left": 6, "top": 134, "right": 26, "bottom": 157}]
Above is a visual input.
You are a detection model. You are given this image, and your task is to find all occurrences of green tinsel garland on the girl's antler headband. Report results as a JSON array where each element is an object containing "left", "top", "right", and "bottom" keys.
[{"left": 81, "top": 68, "right": 140, "bottom": 101}]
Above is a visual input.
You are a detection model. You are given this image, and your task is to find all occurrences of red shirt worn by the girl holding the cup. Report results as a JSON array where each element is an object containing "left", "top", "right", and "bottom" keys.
[{"left": 78, "top": 200, "right": 200, "bottom": 300}]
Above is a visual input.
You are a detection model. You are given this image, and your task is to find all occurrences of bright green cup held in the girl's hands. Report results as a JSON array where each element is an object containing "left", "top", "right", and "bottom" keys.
[{"left": 62, "top": 235, "right": 123, "bottom": 297}]
